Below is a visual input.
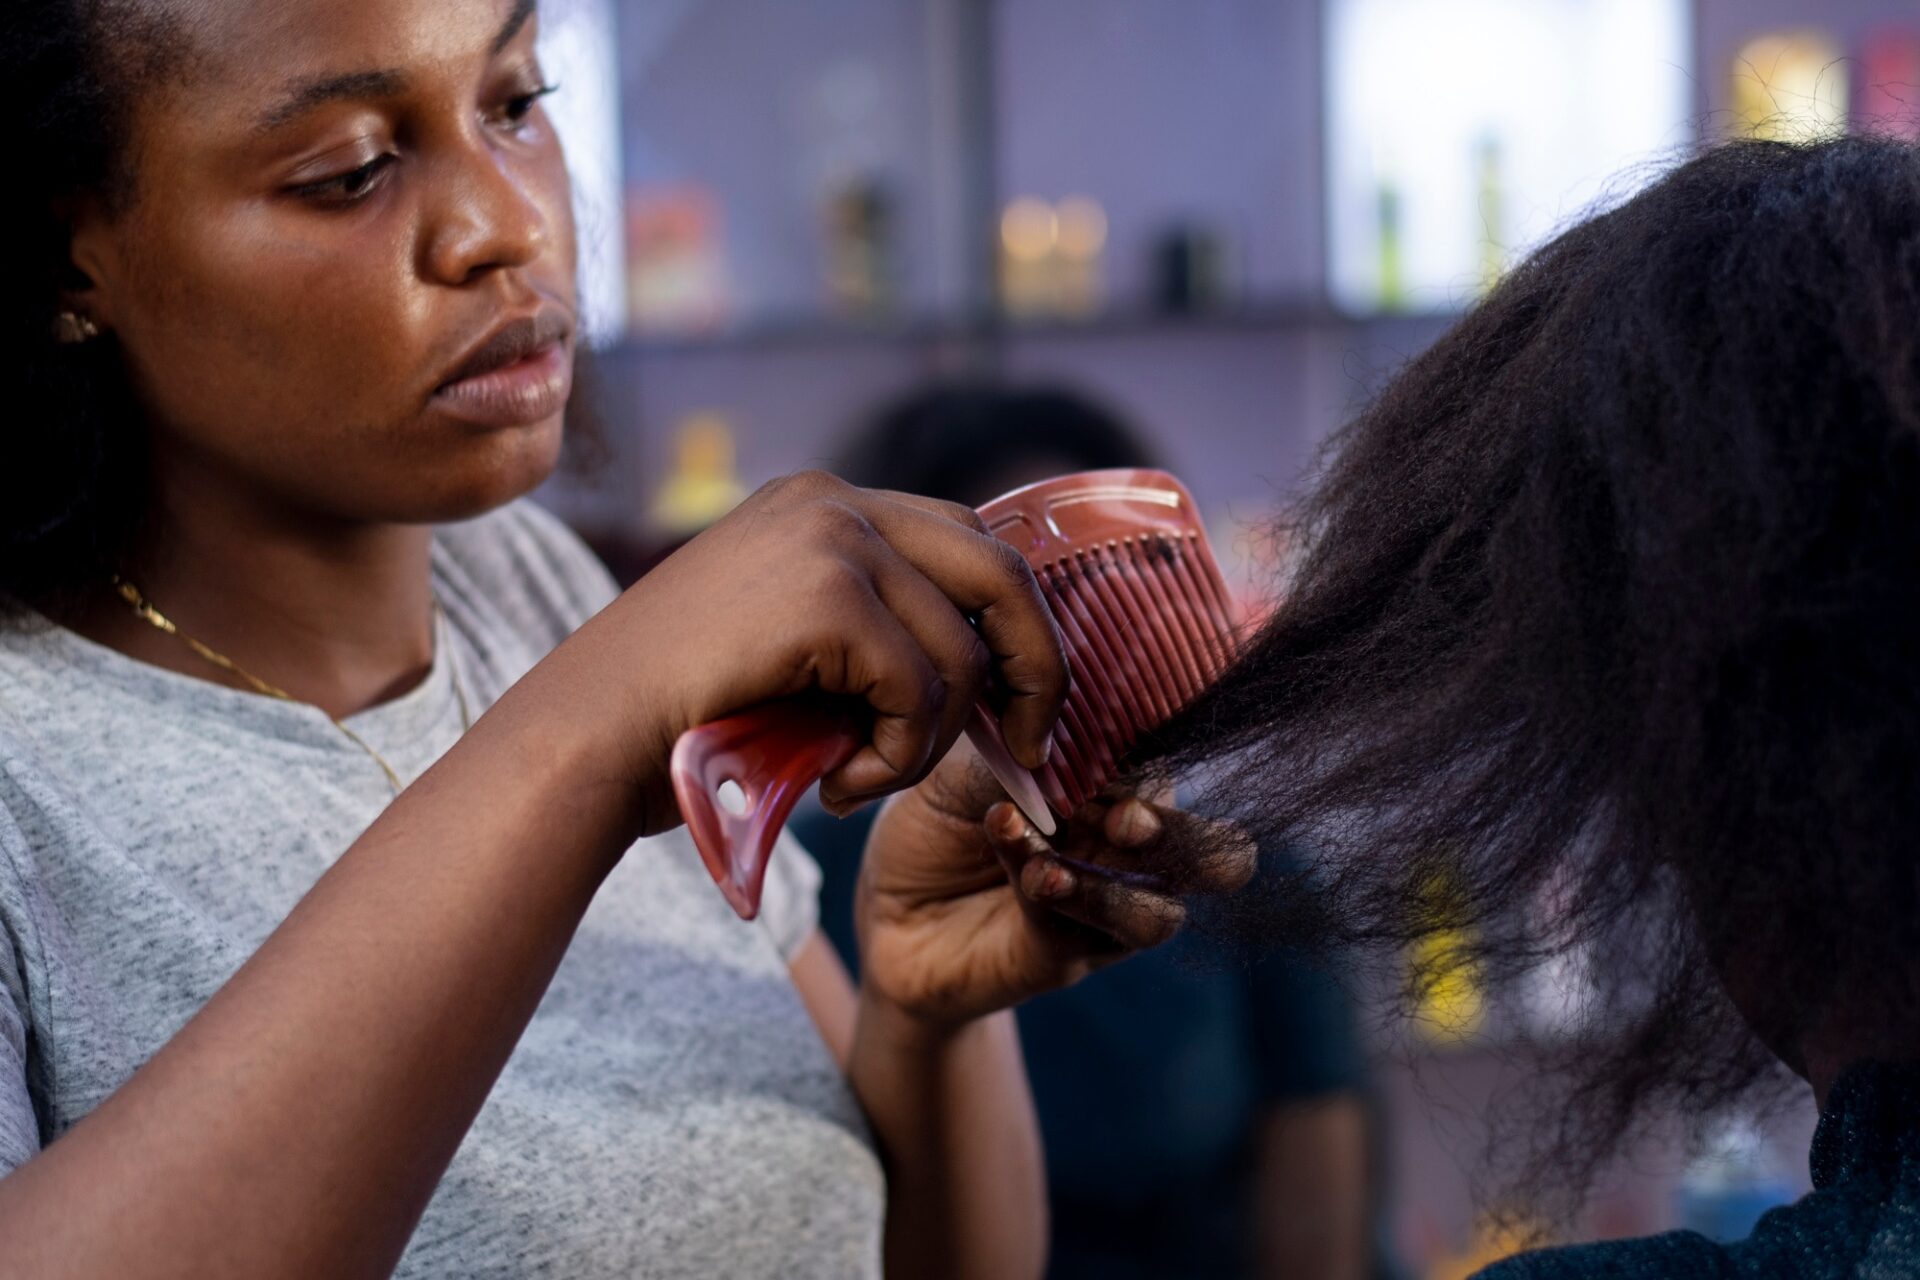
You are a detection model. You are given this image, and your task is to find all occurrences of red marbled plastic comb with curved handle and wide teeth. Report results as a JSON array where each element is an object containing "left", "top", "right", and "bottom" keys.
[{"left": 672, "top": 470, "right": 1240, "bottom": 919}]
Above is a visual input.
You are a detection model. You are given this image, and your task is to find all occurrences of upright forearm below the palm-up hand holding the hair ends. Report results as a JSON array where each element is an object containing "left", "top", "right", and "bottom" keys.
[{"left": 847, "top": 996, "right": 1046, "bottom": 1280}]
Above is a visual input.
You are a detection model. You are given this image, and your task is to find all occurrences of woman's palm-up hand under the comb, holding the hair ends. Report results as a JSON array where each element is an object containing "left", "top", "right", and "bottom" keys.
[{"left": 854, "top": 741, "right": 1254, "bottom": 1025}]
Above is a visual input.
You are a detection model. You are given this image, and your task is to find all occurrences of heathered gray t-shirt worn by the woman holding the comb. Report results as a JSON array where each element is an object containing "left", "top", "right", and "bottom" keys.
[{"left": 0, "top": 503, "right": 885, "bottom": 1280}]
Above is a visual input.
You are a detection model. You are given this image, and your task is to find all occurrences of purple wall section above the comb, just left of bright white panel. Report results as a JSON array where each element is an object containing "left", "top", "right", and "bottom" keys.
[{"left": 995, "top": 0, "right": 1321, "bottom": 301}]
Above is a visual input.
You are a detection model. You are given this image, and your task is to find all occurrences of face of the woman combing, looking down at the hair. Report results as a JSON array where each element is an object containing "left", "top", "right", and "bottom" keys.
[{"left": 71, "top": 0, "right": 574, "bottom": 522}]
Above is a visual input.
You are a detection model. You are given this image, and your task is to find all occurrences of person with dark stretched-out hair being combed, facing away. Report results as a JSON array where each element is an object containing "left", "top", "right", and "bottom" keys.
[{"left": 1136, "top": 138, "right": 1920, "bottom": 1280}]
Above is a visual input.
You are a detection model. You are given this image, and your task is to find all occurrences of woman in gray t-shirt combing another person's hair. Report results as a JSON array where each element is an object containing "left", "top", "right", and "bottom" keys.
[{"left": 0, "top": 0, "right": 1246, "bottom": 1276}]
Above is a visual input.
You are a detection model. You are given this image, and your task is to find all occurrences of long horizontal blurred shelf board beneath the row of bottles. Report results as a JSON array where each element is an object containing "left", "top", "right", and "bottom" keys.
[{"left": 609, "top": 297, "right": 1461, "bottom": 357}]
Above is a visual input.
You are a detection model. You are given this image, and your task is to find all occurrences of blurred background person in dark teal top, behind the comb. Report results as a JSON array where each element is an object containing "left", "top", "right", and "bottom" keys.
[{"left": 791, "top": 382, "right": 1397, "bottom": 1280}]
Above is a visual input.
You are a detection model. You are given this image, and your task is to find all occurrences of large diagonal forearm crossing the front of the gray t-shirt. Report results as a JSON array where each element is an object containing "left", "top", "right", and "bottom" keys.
[{"left": 0, "top": 671, "right": 637, "bottom": 1276}]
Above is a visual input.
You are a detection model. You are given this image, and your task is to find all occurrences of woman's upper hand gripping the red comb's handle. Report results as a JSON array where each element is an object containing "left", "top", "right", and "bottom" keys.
[{"left": 555, "top": 472, "right": 1068, "bottom": 833}]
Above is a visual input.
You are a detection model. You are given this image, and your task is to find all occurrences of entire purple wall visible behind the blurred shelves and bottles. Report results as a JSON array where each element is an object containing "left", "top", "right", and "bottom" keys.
[{"left": 561, "top": 0, "right": 1920, "bottom": 520}]
